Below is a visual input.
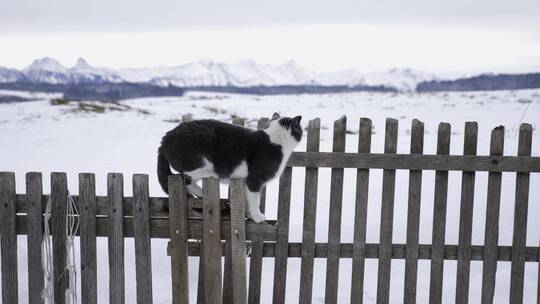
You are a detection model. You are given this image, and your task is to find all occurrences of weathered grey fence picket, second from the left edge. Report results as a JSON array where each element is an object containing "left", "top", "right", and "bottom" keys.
[{"left": 25, "top": 172, "right": 44, "bottom": 304}]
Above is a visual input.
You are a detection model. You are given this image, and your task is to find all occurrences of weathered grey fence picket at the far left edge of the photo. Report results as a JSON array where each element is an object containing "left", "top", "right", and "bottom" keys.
[{"left": 0, "top": 172, "right": 19, "bottom": 304}]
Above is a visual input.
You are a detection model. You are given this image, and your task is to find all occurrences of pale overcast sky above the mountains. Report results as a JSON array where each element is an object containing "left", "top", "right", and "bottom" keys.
[{"left": 0, "top": 0, "right": 540, "bottom": 72}]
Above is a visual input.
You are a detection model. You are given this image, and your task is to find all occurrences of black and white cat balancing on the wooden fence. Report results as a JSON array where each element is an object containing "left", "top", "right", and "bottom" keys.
[{"left": 157, "top": 113, "right": 302, "bottom": 223}]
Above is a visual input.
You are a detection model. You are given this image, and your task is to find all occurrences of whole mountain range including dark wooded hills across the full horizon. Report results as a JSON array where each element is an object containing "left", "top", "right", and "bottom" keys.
[{"left": 0, "top": 57, "right": 540, "bottom": 95}]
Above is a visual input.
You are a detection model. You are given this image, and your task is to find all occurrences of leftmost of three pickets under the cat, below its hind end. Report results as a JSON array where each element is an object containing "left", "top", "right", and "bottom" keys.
[{"left": 169, "top": 175, "right": 189, "bottom": 304}]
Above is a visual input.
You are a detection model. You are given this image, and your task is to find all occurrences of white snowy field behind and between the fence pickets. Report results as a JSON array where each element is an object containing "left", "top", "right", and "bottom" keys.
[{"left": 0, "top": 90, "right": 540, "bottom": 303}]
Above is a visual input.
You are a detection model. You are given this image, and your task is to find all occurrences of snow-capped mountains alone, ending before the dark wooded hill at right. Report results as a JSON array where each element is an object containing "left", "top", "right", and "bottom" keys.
[{"left": 0, "top": 57, "right": 436, "bottom": 91}]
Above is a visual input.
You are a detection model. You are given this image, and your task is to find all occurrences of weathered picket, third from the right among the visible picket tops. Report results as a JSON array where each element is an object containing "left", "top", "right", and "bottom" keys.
[{"left": 456, "top": 122, "right": 478, "bottom": 304}]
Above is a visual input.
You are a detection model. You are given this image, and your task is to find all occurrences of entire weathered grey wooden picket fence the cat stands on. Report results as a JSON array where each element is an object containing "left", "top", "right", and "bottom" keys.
[{"left": 0, "top": 117, "right": 540, "bottom": 303}]
